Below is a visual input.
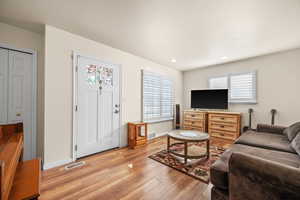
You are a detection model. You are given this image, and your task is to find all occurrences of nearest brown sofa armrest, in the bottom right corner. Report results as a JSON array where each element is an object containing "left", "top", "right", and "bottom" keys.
[{"left": 229, "top": 153, "right": 300, "bottom": 200}]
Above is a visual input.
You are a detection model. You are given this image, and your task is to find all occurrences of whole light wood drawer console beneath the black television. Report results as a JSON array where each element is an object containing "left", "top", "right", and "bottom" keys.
[{"left": 183, "top": 110, "right": 241, "bottom": 143}]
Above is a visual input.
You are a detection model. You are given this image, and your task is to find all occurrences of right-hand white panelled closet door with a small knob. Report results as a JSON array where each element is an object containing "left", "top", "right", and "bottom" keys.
[{"left": 8, "top": 51, "right": 35, "bottom": 160}]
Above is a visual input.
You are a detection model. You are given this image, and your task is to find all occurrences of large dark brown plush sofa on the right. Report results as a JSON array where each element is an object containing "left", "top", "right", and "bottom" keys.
[{"left": 210, "top": 125, "right": 300, "bottom": 200}]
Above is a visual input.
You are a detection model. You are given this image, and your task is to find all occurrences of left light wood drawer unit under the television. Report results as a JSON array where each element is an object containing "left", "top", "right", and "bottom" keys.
[{"left": 183, "top": 110, "right": 207, "bottom": 132}]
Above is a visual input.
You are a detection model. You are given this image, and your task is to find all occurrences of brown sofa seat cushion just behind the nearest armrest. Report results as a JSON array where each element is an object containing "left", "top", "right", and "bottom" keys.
[{"left": 210, "top": 144, "right": 300, "bottom": 190}]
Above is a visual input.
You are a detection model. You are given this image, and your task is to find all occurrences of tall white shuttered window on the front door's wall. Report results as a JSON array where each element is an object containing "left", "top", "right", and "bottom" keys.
[{"left": 142, "top": 71, "right": 174, "bottom": 122}]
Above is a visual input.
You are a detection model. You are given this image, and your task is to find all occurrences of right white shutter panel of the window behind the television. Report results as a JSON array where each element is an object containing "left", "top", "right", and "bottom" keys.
[{"left": 229, "top": 72, "right": 256, "bottom": 103}]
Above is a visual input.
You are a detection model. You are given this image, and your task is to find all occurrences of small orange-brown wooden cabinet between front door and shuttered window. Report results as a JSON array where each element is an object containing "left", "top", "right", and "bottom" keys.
[{"left": 128, "top": 122, "right": 148, "bottom": 149}]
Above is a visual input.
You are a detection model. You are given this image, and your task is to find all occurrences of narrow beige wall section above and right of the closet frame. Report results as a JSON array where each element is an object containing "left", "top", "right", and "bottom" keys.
[{"left": 0, "top": 23, "right": 44, "bottom": 157}]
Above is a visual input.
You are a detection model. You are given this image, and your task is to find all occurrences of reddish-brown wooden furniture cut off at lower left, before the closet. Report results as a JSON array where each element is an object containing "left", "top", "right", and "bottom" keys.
[{"left": 0, "top": 123, "right": 41, "bottom": 200}]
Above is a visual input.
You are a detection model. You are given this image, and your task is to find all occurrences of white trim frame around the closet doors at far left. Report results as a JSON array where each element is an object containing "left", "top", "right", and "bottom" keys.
[{"left": 0, "top": 43, "right": 37, "bottom": 159}]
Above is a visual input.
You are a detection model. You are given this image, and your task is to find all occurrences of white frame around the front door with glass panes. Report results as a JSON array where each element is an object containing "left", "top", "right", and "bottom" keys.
[{"left": 71, "top": 51, "right": 123, "bottom": 162}]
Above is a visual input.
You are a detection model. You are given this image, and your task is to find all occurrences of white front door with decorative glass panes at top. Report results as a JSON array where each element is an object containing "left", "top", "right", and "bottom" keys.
[{"left": 76, "top": 56, "right": 120, "bottom": 158}]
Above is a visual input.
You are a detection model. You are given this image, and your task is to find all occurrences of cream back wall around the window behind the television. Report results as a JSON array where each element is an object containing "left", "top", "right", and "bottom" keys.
[{"left": 183, "top": 49, "right": 300, "bottom": 128}]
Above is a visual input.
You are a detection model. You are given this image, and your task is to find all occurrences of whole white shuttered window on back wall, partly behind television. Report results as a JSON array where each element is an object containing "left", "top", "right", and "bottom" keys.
[{"left": 208, "top": 72, "right": 256, "bottom": 103}]
